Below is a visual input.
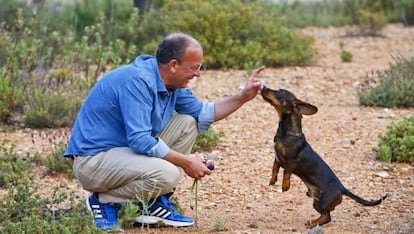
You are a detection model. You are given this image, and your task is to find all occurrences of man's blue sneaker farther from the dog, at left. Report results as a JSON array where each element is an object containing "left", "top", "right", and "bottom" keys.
[{"left": 86, "top": 193, "right": 122, "bottom": 231}]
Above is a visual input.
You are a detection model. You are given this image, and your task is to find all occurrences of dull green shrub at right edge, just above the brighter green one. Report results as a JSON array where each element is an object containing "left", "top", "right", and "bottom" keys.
[{"left": 359, "top": 58, "right": 414, "bottom": 107}]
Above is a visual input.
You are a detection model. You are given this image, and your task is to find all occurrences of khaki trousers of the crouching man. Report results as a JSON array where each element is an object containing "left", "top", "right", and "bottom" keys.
[{"left": 73, "top": 114, "right": 198, "bottom": 203}]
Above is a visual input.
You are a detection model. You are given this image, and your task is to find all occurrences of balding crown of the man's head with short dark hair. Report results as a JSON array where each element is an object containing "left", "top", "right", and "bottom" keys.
[{"left": 156, "top": 32, "right": 202, "bottom": 64}]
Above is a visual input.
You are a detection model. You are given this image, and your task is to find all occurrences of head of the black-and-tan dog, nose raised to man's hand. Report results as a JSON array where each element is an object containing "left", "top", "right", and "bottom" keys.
[{"left": 262, "top": 86, "right": 318, "bottom": 116}]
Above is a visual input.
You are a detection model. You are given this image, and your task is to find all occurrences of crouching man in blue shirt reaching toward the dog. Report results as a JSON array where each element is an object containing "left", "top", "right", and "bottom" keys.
[{"left": 64, "top": 32, "right": 264, "bottom": 229}]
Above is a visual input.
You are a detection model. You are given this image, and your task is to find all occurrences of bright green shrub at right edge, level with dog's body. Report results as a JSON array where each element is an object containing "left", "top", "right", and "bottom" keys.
[{"left": 377, "top": 116, "right": 414, "bottom": 163}]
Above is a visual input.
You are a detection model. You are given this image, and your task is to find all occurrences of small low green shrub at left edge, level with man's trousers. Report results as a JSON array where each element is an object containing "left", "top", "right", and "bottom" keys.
[{"left": 0, "top": 141, "right": 34, "bottom": 187}]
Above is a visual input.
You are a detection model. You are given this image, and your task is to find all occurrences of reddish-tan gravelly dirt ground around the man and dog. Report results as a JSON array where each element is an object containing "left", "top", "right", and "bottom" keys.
[{"left": 0, "top": 25, "right": 414, "bottom": 234}]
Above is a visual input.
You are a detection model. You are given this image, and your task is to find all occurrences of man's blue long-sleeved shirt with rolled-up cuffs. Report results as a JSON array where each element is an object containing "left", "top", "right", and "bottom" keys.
[{"left": 64, "top": 55, "right": 214, "bottom": 157}]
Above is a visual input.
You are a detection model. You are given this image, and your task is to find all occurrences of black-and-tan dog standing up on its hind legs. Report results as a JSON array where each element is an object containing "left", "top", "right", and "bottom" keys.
[{"left": 261, "top": 86, "right": 387, "bottom": 228}]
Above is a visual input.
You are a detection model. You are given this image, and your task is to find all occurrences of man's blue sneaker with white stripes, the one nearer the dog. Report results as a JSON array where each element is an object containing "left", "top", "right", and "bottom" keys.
[{"left": 135, "top": 195, "right": 194, "bottom": 227}]
